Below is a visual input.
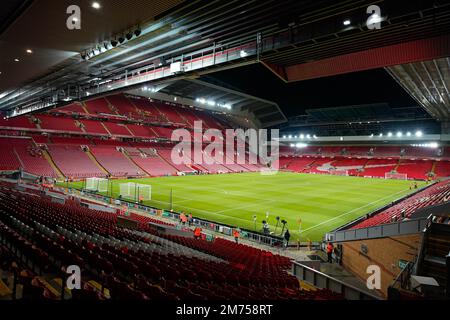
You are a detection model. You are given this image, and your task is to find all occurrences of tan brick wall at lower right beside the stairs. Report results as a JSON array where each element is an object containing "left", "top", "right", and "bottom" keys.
[{"left": 342, "top": 234, "right": 421, "bottom": 298}]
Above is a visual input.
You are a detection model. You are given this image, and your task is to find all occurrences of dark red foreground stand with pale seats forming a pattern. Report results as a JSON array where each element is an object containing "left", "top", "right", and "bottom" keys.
[{"left": 0, "top": 187, "right": 342, "bottom": 300}]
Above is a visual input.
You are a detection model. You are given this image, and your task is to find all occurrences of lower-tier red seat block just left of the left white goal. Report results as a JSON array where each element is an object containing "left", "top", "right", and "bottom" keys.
[{"left": 48, "top": 144, "right": 106, "bottom": 178}]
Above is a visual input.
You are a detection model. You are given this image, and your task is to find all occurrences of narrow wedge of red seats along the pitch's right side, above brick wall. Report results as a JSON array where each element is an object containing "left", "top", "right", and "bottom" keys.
[{"left": 351, "top": 181, "right": 450, "bottom": 229}]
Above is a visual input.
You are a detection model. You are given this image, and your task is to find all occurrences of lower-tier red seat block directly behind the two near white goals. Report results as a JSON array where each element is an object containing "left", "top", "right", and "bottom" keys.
[{"left": 90, "top": 146, "right": 145, "bottom": 177}]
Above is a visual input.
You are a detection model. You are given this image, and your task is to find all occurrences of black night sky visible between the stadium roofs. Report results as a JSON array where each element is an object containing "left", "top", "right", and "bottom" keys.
[{"left": 206, "top": 64, "right": 417, "bottom": 117}]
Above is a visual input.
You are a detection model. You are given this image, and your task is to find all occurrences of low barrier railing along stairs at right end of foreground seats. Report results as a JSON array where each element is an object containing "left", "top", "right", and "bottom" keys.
[{"left": 292, "top": 261, "right": 382, "bottom": 300}]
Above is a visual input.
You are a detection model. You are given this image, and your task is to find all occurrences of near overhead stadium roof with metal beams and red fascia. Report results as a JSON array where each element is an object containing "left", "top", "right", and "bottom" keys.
[{"left": 0, "top": 0, "right": 450, "bottom": 125}]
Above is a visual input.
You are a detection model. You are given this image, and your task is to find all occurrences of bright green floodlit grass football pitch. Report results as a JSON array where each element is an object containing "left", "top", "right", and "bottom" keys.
[{"left": 64, "top": 172, "right": 423, "bottom": 241}]
